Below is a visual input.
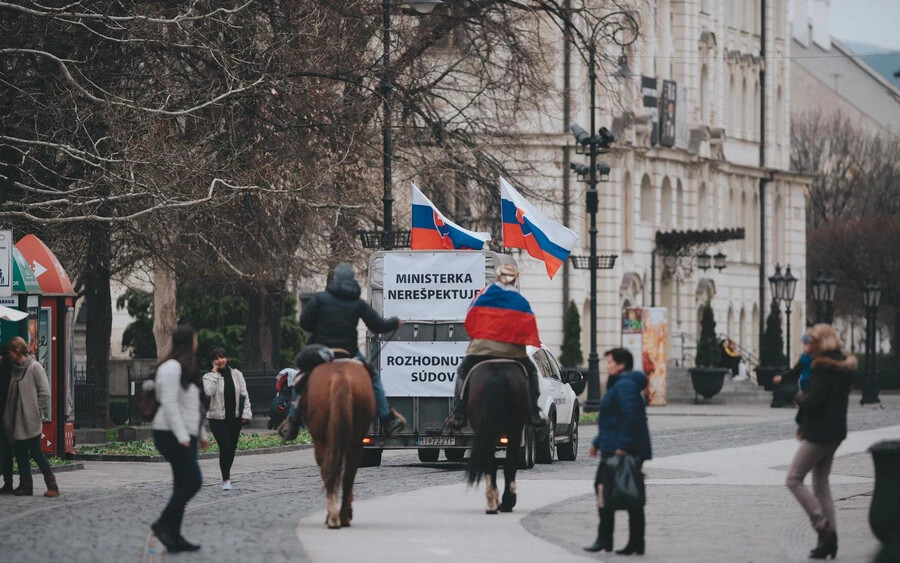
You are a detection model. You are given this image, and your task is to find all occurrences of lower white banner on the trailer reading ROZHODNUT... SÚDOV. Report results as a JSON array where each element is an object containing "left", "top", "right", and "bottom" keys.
[{"left": 380, "top": 341, "right": 469, "bottom": 397}]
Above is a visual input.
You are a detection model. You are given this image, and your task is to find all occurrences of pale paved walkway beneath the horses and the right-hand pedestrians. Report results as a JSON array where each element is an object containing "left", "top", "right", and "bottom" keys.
[{"left": 296, "top": 426, "right": 900, "bottom": 563}]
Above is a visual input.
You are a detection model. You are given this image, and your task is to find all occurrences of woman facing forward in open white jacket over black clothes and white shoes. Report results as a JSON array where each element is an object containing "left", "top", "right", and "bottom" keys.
[{"left": 203, "top": 348, "right": 253, "bottom": 491}]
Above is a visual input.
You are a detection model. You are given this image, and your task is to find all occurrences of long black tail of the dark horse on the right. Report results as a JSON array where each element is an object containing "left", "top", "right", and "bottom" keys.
[{"left": 467, "top": 371, "right": 509, "bottom": 485}]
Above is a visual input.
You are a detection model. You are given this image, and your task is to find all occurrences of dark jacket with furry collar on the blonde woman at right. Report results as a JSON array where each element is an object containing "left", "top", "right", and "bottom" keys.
[{"left": 795, "top": 351, "right": 856, "bottom": 443}]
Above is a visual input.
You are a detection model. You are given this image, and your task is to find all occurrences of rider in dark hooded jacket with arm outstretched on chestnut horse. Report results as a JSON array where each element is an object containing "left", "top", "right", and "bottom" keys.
[{"left": 300, "top": 262, "right": 406, "bottom": 436}]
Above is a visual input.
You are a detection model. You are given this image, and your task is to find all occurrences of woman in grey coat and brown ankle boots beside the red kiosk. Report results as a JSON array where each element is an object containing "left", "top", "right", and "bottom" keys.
[{"left": 3, "top": 336, "right": 59, "bottom": 497}]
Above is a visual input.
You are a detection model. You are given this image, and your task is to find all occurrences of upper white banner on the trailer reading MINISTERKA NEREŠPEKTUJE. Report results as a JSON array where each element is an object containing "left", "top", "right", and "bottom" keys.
[{"left": 383, "top": 251, "right": 484, "bottom": 321}]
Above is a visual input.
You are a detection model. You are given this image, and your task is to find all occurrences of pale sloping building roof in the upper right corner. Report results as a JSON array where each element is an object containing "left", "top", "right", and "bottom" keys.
[{"left": 791, "top": 38, "right": 900, "bottom": 135}]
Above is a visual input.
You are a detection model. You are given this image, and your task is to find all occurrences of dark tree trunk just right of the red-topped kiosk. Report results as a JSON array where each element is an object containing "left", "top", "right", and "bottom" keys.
[{"left": 84, "top": 223, "right": 112, "bottom": 427}]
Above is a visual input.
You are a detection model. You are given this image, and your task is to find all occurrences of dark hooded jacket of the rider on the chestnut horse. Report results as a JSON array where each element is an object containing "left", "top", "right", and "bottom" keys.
[{"left": 300, "top": 263, "right": 400, "bottom": 355}]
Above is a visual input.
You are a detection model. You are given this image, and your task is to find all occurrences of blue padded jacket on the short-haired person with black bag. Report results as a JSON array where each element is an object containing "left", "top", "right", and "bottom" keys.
[{"left": 593, "top": 371, "right": 652, "bottom": 460}]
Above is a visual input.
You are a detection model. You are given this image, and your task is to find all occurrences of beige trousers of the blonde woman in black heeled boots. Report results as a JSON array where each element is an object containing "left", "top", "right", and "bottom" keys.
[{"left": 785, "top": 440, "right": 840, "bottom": 532}]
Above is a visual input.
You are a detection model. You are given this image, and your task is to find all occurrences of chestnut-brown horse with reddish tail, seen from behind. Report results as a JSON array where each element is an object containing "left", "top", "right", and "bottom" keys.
[{"left": 300, "top": 360, "right": 375, "bottom": 528}]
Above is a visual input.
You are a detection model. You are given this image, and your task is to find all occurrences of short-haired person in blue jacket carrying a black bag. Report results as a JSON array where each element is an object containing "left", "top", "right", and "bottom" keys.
[{"left": 584, "top": 348, "right": 652, "bottom": 555}]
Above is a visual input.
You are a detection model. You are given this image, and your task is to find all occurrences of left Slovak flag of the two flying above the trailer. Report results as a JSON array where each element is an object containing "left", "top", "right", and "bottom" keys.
[{"left": 409, "top": 184, "right": 491, "bottom": 250}]
